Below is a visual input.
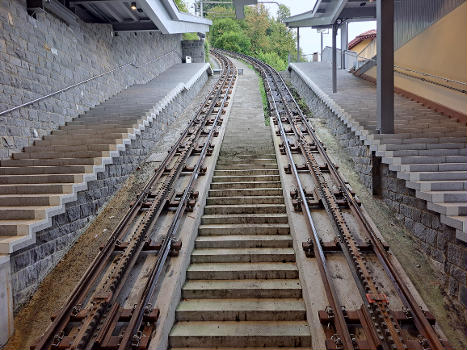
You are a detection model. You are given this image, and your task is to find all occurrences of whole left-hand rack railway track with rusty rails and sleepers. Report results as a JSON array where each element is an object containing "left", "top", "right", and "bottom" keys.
[{"left": 31, "top": 53, "right": 237, "bottom": 349}]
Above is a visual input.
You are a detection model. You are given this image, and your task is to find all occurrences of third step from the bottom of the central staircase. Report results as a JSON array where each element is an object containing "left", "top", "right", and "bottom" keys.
[{"left": 182, "top": 279, "right": 302, "bottom": 299}]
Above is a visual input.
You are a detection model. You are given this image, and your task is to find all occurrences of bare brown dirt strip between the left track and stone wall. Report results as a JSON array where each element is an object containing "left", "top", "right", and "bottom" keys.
[{"left": 4, "top": 76, "right": 218, "bottom": 350}]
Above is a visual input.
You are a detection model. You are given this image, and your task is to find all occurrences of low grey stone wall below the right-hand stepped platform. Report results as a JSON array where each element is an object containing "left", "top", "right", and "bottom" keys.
[{"left": 290, "top": 70, "right": 467, "bottom": 307}]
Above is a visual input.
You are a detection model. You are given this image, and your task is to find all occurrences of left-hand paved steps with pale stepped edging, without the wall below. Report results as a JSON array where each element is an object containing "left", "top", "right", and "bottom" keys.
[{"left": 0, "top": 64, "right": 207, "bottom": 254}]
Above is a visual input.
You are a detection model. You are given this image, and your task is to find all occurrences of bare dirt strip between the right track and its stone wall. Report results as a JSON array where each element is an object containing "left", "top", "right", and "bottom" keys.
[{"left": 309, "top": 118, "right": 467, "bottom": 349}]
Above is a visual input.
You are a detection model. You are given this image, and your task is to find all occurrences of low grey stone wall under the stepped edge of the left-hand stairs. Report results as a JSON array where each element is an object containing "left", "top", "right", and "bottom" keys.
[{"left": 10, "top": 73, "right": 207, "bottom": 310}]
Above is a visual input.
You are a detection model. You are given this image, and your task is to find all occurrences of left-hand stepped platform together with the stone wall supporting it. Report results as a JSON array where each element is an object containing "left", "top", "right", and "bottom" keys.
[{"left": 0, "top": 63, "right": 211, "bottom": 329}]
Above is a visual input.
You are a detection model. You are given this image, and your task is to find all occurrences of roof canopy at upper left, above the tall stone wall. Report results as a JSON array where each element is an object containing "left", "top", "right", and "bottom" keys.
[{"left": 23, "top": 0, "right": 212, "bottom": 34}]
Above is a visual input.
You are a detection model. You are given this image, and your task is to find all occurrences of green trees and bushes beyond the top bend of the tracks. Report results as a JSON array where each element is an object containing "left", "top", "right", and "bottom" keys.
[{"left": 209, "top": 5, "right": 297, "bottom": 70}]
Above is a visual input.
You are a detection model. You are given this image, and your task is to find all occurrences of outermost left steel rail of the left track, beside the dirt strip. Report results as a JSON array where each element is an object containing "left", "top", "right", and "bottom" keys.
[{"left": 34, "top": 49, "right": 228, "bottom": 349}]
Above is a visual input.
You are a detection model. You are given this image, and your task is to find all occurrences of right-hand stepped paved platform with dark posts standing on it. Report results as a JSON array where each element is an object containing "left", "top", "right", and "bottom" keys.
[{"left": 289, "top": 62, "right": 467, "bottom": 242}]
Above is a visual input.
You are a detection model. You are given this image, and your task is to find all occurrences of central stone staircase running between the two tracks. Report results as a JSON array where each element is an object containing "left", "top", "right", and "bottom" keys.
[{"left": 169, "top": 154, "right": 311, "bottom": 350}]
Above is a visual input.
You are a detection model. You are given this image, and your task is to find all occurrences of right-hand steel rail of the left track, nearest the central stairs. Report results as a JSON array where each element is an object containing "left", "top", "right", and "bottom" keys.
[{"left": 118, "top": 50, "right": 236, "bottom": 350}]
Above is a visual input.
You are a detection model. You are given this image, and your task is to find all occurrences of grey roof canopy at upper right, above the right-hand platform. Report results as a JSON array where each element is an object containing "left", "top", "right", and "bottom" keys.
[{"left": 284, "top": 0, "right": 376, "bottom": 28}]
